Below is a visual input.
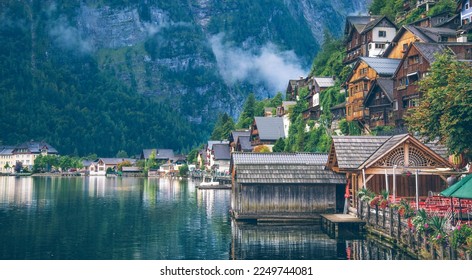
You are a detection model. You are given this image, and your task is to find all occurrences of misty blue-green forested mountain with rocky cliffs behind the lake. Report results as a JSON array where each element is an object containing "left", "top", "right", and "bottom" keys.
[{"left": 0, "top": 0, "right": 368, "bottom": 156}]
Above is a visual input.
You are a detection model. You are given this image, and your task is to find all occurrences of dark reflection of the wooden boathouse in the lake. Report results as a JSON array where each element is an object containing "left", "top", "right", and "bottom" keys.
[{"left": 230, "top": 221, "right": 346, "bottom": 260}]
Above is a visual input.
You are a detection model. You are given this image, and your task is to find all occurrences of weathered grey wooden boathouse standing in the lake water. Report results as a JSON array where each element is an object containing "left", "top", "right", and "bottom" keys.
[{"left": 231, "top": 153, "right": 346, "bottom": 220}]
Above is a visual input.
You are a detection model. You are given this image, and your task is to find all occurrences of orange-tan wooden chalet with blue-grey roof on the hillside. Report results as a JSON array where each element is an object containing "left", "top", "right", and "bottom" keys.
[{"left": 346, "top": 57, "right": 400, "bottom": 130}]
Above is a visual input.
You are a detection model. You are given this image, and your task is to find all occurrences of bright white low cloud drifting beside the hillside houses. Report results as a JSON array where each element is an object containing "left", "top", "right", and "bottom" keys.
[{"left": 210, "top": 34, "right": 307, "bottom": 94}]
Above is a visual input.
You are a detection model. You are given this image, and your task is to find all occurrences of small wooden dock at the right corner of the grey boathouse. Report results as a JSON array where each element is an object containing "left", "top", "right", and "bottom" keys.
[{"left": 320, "top": 214, "right": 366, "bottom": 238}]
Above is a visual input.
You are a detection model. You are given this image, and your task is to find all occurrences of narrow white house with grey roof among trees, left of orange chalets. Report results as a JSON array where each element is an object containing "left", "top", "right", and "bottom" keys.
[{"left": 302, "top": 77, "right": 335, "bottom": 120}]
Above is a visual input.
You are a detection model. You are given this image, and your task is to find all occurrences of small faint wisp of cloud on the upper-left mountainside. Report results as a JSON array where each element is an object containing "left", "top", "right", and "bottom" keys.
[{"left": 49, "top": 18, "right": 93, "bottom": 54}]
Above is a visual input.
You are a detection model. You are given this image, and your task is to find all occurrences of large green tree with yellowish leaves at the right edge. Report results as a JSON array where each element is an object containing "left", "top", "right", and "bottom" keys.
[{"left": 405, "top": 52, "right": 472, "bottom": 158}]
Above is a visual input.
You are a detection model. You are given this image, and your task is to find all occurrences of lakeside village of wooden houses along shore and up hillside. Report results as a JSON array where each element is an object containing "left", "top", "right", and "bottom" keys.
[{"left": 0, "top": 0, "right": 472, "bottom": 259}]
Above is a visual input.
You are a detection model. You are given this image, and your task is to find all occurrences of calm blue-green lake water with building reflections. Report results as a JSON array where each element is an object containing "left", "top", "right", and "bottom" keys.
[{"left": 0, "top": 177, "right": 408, "bottom": 260}]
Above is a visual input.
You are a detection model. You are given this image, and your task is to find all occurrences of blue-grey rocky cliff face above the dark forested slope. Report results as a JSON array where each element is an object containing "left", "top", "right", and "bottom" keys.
[{"left": 62, "top": 0, "right": 368, "bottom": 120}]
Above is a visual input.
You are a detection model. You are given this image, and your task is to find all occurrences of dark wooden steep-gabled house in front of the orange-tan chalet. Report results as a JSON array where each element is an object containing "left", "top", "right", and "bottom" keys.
[{"left": 364, "top": 78, "right": 395, "bottom": 130}]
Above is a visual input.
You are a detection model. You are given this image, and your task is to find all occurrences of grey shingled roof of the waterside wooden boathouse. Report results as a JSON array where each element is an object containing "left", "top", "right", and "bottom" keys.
[{"left": 232, "top": 153, "right": 346, "bottom": 184}]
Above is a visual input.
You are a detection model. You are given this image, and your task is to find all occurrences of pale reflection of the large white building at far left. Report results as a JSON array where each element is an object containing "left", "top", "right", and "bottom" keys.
[{"left": 0, "top": 176, "right": 33, "bottom": 207}]
